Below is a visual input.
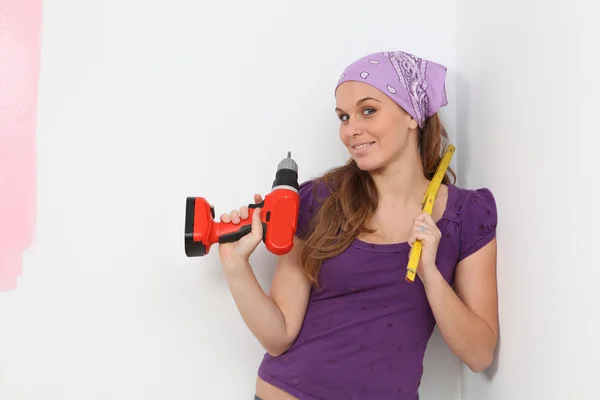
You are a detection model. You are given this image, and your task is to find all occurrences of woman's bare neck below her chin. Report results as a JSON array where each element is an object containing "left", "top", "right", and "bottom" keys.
[{"left": 371, "top": 149, "right": 429, "bottom": 205}]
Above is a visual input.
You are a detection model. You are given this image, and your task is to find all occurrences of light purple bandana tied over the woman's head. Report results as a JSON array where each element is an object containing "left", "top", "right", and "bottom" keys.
[{"left": 336, "top": 51, "right": 448, "bottom": 128}]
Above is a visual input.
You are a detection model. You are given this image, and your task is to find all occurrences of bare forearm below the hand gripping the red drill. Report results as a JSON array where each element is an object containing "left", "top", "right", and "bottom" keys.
[{"left": 223, "top": 261, "right": 288, "bottom": 355}]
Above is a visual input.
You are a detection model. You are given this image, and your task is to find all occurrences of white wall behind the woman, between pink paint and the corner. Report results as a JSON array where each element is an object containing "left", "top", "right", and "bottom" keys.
[{"left": 0, "top": 0, "right": 464, "bottom": 400}]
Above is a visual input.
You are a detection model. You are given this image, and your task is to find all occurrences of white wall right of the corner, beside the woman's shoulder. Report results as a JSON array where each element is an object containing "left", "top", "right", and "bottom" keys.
[{"left": 457, "top": 0, "right": 600, "bottom": 400}]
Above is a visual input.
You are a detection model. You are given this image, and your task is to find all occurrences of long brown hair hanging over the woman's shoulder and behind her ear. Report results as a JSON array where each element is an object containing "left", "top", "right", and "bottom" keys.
[{"left": 301, "top": 114, "right": 456, "bottom": 286}]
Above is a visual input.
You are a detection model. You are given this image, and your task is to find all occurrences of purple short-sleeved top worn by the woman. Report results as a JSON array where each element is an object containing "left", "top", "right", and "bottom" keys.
[{"left": 258, "top": 180, "right": 497, "bottom": 400}]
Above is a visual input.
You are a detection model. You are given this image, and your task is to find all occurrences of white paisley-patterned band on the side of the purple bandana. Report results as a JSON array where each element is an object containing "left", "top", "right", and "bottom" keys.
[{"left": 383, "top": 51, "right": 429, "bottom": 128}]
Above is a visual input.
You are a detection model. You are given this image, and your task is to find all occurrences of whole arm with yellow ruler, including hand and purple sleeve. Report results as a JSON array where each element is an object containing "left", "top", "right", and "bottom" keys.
[{"left": 409, "top": 189, "right": 498, "bottom": 372}]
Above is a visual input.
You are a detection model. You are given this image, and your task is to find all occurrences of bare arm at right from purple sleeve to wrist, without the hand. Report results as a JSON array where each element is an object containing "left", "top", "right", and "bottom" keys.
[{"left": 421, "top": 238, "right": 498, "bottom": 372}]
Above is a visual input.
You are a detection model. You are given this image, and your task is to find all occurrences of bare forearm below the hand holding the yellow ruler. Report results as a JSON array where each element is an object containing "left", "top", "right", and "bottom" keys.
[{"left": 423, "top": 269, "right": 496, "bottom": 372}]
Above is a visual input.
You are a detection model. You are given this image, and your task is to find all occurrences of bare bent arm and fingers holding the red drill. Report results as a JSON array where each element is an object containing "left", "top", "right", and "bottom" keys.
[{"left": 220, "top": 198, "right": 311, "bottom": 357}]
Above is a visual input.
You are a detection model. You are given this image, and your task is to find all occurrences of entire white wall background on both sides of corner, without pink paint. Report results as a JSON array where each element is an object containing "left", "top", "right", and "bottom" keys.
[{"left": 0, "top": 0, "right": 600, "bottom": 400}]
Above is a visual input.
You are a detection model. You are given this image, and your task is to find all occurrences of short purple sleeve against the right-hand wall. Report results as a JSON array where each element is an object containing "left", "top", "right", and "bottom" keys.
[{"left": 458, "top": 188, "right": 498, "bottom": 261}]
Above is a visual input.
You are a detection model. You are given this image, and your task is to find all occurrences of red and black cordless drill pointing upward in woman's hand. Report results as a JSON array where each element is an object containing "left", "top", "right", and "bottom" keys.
[{"left": 184, "top": 152, "right": 300, "bottom": 257}]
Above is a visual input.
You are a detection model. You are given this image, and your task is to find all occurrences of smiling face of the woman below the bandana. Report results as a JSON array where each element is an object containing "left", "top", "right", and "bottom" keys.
[{"left": 336, "top": 81, "right": 418, "bottom": 171}]
